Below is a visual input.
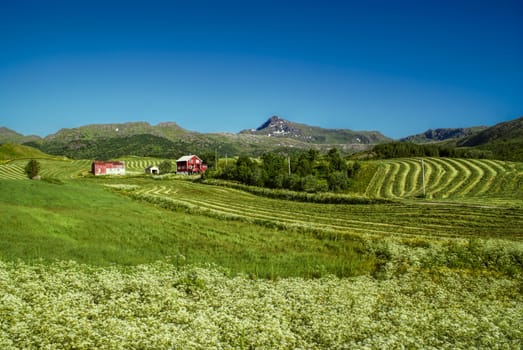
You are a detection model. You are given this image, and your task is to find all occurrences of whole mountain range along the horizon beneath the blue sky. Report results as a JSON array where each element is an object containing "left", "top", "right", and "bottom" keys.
[{"left": 0, "top": 116, "right": 523, "bottom": 160}]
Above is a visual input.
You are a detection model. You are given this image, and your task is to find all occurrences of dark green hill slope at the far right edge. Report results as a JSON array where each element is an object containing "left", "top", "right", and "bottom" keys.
[{"left": 457, "top": 117, "right": 523, "bottom": 161}]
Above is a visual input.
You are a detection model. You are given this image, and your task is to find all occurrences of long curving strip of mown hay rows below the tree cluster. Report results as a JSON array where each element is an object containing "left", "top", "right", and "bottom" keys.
[{"left": 126, "top": 181, "right": 523, "bottom": 239}]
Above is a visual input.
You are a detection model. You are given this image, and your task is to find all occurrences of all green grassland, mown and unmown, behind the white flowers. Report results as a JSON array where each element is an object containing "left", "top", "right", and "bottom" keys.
[{"left": 0, "top": 157, "right": 523, "bottom": 278}]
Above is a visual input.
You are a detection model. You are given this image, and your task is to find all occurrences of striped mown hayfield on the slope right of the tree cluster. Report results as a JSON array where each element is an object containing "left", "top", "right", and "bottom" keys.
[{"left": 365, "top": 158, "right": 523, "bottom": 199}]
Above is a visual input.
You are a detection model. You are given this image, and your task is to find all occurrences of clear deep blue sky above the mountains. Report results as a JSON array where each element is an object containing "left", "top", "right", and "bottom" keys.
[{"left": 0, "top": 0, "right": 523, "bottom": 138}]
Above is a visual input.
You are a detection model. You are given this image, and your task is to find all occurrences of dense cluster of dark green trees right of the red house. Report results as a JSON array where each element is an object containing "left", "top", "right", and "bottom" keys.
[{"left": 206, "top": 148, "right": 359, "bottom": 192}]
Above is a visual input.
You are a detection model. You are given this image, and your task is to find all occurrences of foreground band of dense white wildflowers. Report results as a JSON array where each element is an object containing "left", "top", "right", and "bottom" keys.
[{"left": 0, "top": 262, "right": 523, "bottom": 349}]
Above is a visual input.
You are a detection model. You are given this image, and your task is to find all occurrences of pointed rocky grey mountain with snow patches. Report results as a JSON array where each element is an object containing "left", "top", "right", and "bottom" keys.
[{"left": 240, "top": 116, "right": 391, "bottom": 145}]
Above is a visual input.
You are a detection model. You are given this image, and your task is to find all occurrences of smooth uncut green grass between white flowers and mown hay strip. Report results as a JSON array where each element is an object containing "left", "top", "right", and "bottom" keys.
[{"left": 0, "top": 180, "right": 376, "bottom": 278}]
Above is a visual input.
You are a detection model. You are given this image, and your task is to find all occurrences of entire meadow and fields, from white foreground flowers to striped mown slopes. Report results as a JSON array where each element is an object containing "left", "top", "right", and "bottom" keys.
[{"left": 0, "top": 157, "right": 523, "bottom": 349}]
